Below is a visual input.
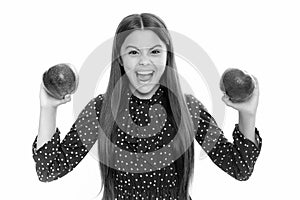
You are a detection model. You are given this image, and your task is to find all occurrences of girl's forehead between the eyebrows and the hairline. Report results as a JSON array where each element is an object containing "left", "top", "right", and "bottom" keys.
[{"left": 122, "top": 30, "right": 165, "bottom": 49}]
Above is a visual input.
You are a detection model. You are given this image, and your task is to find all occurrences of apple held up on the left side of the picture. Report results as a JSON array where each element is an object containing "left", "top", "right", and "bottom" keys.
[{"left": 43, "top": 63, "right": 79, "bottom": 99}]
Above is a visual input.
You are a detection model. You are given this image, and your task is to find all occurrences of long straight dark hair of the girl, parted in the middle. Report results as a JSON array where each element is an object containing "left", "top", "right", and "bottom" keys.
[{"left": 98, "top": 13, "right": 194, "bottom": 200}]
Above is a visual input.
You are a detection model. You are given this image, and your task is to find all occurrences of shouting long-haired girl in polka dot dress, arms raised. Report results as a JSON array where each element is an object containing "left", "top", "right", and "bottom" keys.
[{"left": 32, "top": 13, "right": 262, "bottom": 200}]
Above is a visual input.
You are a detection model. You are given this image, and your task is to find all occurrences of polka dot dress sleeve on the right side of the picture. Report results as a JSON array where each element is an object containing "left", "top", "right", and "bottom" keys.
[{"left": 187, "top": 95, "right": 262, "bottom": 181}]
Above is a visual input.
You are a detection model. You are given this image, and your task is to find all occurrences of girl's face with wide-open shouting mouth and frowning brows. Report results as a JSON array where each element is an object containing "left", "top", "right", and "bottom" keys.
[{"left": 121, "top": 30, "right": 167, "bottom": 98}]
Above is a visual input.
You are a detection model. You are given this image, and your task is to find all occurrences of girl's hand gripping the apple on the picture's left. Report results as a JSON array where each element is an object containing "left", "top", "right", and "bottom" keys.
[{"left": 40, "top": 83, "right": 71, "bottom": 108}]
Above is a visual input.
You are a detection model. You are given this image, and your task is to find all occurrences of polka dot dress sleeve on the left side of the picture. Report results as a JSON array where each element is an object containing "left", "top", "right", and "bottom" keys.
[{"left": 32, "top": 94, "right": 103, "bottom": 182}]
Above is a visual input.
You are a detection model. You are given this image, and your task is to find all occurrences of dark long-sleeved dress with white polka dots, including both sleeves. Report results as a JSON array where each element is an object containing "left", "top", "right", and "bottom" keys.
[{"left": 32, "top": 85, "right": 262, "bottom": 200}]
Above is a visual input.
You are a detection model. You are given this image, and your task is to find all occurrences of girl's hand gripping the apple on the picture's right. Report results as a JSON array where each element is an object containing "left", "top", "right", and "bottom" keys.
[{"left": 222, "top": 75, "right": 259, "bottom": 116}]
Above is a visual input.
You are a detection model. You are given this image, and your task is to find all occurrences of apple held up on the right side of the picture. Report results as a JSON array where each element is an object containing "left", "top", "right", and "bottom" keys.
[{"left": 220, "top": 68, "right": 255, "bottom": 103}]
